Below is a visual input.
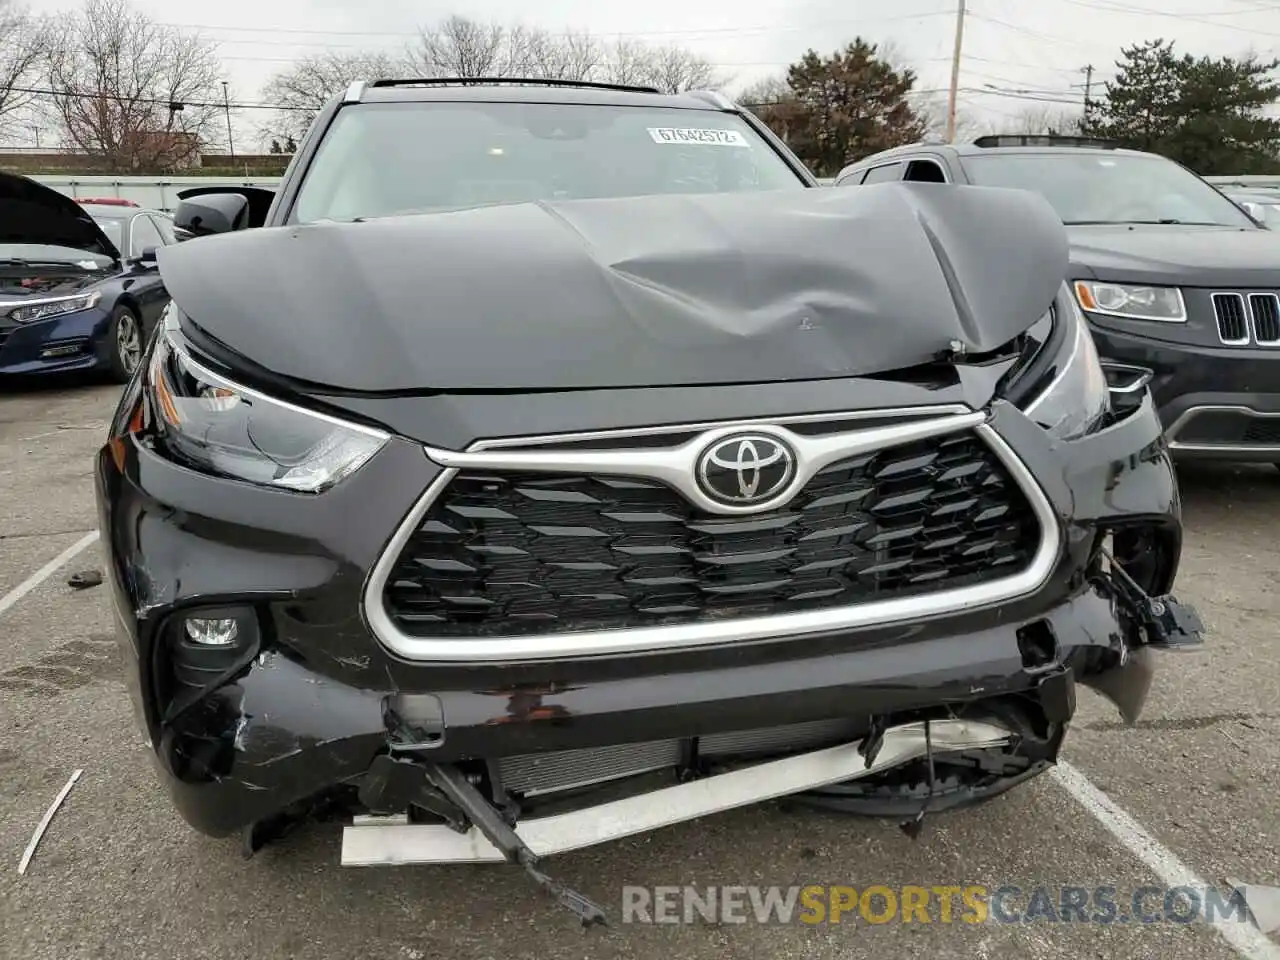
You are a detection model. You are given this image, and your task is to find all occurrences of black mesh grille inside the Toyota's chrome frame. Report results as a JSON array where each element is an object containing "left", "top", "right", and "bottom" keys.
[{"left": 385, "top": 433, "right": 1039, "bottom": 637}]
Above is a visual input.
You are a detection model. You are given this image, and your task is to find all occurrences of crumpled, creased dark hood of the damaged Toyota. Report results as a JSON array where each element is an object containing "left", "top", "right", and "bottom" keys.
[{"left": 160, "top": 184, "right": 1068, "bottom": 392}]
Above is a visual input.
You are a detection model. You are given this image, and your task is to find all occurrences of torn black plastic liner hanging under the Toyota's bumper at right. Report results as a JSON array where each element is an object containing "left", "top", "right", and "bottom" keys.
[{"left": 788, "top": 704, "right": 1066, "bottom": 819}]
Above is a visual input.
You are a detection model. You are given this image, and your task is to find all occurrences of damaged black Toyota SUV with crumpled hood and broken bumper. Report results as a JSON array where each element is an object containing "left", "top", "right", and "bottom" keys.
[{"left": 96, "top": 81, "right": 1201, "bottom": 922}]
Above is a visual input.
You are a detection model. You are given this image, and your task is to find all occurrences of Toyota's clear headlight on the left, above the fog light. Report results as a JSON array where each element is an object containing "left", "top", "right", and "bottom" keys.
[{"left": 147, "top": 334, "right": 389, "bottom": 493}]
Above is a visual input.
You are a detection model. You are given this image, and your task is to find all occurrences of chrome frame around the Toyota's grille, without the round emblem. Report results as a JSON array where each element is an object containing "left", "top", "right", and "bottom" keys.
[{"left": 364, "top": 404, "right": 1061, "bottom": 663}]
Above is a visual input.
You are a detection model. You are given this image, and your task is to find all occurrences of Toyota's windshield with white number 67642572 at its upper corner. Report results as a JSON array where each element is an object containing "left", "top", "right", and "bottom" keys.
[{"left": 291, "top": 102, "right": 806, "bottom": 223}]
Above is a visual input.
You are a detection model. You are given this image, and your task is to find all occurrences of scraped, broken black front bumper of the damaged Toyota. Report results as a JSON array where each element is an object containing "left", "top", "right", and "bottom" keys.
[{"left": 96, "top": 386, "right": 1181, "bottom": 835}]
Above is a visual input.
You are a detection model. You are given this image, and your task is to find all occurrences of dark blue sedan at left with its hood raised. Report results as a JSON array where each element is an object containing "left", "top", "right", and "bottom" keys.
[{"left": 0, "top": 173, "right": 174, "bottom": 381}]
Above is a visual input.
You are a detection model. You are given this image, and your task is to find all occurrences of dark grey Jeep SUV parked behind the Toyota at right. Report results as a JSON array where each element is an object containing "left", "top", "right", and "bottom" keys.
[{"left": 836, "top": 136, "right": 1280, "bottom": 465}]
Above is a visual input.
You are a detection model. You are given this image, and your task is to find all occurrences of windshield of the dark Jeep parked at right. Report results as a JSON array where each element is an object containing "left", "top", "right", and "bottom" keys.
[{"left": 961, "top": 150, "right": 1254, "bottom": 228}]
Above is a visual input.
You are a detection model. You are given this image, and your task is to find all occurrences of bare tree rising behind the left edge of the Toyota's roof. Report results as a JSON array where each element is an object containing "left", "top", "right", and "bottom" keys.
[{"left": 261, "top": 52, "right": 408, "bottom": 146}]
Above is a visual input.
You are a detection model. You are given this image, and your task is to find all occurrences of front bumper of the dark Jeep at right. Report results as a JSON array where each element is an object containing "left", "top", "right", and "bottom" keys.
[{"left": 1089, "top": 316, "right": 1280, "bottom": 463}]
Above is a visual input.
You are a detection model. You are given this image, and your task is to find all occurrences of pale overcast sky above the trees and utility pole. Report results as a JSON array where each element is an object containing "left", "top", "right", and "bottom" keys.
[{"left": 28, "top": 0, "right": 1280, "bottom": 150}]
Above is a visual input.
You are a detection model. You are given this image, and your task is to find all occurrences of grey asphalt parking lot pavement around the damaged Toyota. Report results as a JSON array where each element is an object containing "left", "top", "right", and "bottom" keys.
[{"left": 0, "top": 384, "right": 1280, "bottom": 960}]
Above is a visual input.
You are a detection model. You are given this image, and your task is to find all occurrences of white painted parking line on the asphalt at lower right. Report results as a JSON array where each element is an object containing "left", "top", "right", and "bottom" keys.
[{"left": 1051, "top": 760, "right": 1280, "bottom": 960}]
